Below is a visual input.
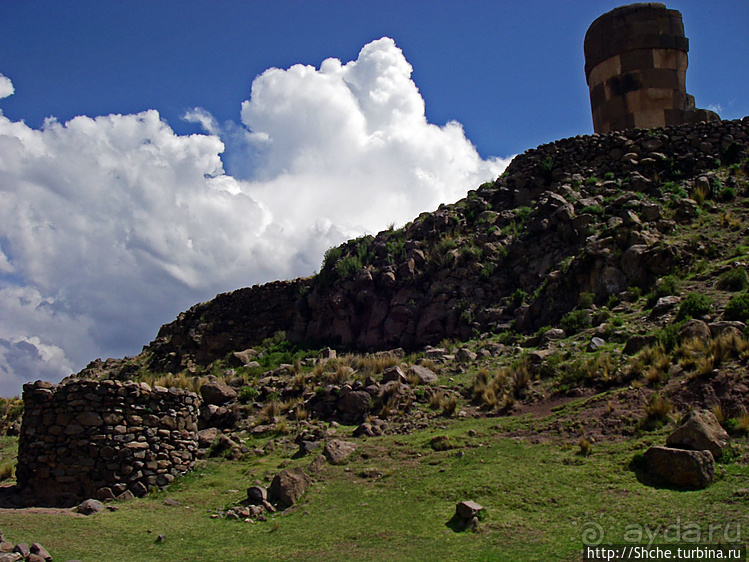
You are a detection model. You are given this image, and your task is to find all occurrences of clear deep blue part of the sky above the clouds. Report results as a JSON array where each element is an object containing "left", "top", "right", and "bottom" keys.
[{"left": 0, "top": 0, "right": 749, "bottom": 157}]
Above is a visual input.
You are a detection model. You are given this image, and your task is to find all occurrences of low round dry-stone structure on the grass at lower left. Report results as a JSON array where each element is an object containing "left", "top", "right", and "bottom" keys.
[{"left": 17, "top": 380, "right": 200, "bottom": 506}]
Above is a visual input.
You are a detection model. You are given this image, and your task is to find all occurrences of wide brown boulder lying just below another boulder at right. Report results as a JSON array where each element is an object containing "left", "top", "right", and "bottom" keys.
[{"left": 644, "top": 445, "right": 715, "bottom": 489}]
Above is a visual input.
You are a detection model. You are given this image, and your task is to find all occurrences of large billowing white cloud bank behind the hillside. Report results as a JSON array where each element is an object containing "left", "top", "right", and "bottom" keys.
[{"left": 0, "top": 38, "right": 507, "bottom": 395}]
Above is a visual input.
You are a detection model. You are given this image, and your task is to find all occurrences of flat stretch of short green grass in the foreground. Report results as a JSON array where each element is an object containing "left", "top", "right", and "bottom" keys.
[{"left": 0, "top": 418, "right": 749, "bottom": 561}]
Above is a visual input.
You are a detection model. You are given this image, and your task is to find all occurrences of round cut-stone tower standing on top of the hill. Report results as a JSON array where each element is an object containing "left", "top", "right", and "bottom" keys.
[{"left": 584, "top": 2, "right": 719, "bottom": 133}]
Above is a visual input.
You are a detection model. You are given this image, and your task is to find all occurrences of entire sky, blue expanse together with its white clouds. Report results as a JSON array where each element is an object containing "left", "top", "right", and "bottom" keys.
[{"left": 0, "top": 0, "right": 749, "bottom": 395}]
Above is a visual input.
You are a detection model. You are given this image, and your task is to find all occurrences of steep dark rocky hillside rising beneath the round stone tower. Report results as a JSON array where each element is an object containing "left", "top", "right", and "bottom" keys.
[{"left": 81, "top": 118, "right": 749, "bottom": 378}]
